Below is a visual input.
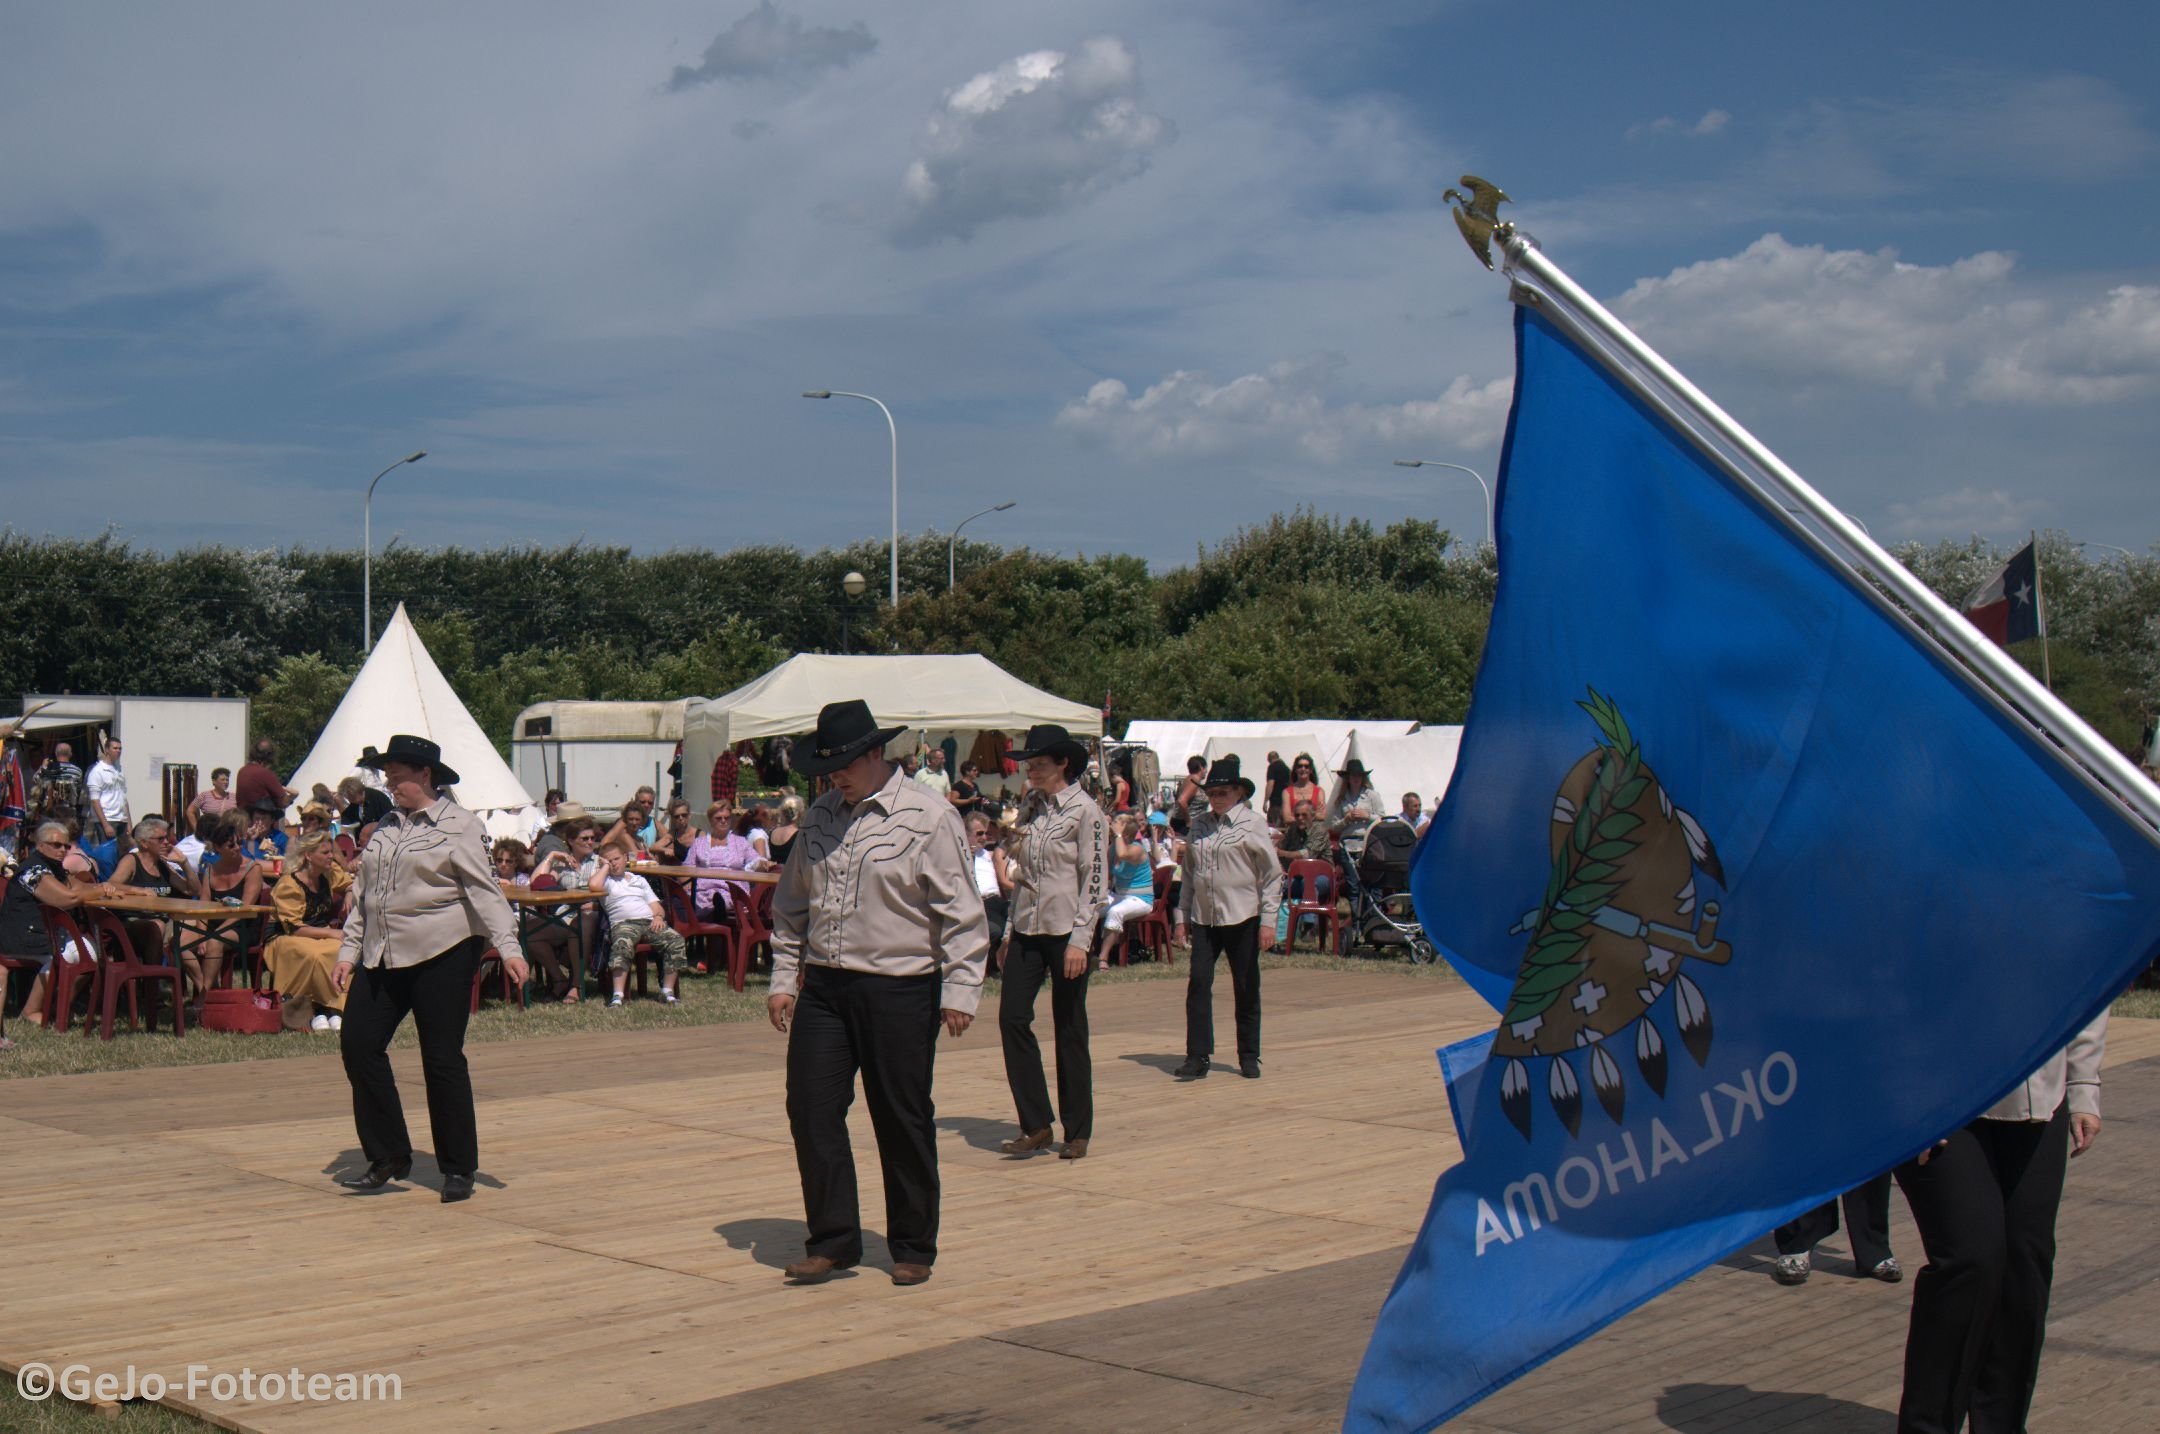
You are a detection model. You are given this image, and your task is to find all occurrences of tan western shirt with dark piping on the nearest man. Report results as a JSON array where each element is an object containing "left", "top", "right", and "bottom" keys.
[{"left": 771, "top": 767, "right": 989, "bottom": 1015}]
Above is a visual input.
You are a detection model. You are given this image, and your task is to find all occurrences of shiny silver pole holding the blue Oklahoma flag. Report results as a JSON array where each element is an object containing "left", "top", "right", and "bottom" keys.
[{"left": 1494, "top": 218, "right": 2160, "bottom": 844}]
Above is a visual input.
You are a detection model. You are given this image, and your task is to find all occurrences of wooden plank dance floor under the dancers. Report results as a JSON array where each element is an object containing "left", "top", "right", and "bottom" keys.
[{"left": 0, "top": 972, "right": 2160, "bottom": 1434}]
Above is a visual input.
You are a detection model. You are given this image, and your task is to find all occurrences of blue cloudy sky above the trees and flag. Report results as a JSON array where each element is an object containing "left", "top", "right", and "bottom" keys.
[{"left": 0, "top": 0, "right": 2160, "bottom": 562}]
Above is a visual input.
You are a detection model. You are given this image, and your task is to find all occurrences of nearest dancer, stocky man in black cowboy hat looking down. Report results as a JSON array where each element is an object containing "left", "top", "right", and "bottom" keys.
[{"left": 767, "top": 702, "right": 989, "bottom": 1285}]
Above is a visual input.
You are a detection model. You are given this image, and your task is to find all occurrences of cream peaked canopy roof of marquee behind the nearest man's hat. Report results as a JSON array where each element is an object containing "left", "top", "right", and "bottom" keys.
[{"left": 683, "top": 652, "right": 1102, "bottom": 790}]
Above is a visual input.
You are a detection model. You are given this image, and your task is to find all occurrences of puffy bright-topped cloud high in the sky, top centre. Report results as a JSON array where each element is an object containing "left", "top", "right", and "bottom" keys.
[{"left": 892, "top": 37, "right": 1177, "bottom": 244}]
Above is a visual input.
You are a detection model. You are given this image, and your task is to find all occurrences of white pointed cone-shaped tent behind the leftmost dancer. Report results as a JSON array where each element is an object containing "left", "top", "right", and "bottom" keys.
[{"left": 292, "top": 603, "right": 538, "bottom": 836}]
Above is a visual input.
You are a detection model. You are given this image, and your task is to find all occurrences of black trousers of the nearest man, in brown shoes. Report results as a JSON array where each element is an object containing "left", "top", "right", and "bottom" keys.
[{"left": 786, "top": 965, "right": 940, "bottom": 1266}]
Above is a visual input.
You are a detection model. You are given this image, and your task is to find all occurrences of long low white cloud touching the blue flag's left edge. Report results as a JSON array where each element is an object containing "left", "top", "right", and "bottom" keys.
[{"left": 1058, "top": 356, "right": 1514, "bottom": 462}]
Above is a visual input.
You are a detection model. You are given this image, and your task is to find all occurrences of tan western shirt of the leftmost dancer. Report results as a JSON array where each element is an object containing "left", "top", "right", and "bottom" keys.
[{"left": 337, "top": 797, "right": 518, "bottom": 968}]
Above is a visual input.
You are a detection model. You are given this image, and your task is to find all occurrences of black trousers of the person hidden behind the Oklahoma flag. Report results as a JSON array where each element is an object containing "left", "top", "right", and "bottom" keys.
[{"left": 1896, "top": 1108, "right": 2069, "bottom": 1434}]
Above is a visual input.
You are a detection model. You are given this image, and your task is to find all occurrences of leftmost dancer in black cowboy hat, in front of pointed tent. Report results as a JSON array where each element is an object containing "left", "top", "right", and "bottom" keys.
[{"left": 330, "top": 734, "right": 527, "bottom": 1203}]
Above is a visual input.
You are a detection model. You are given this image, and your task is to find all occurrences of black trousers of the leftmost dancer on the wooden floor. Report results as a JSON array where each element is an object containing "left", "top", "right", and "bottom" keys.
[{"left": 337, "top": 935, "right": 486, "bottom": 1175}]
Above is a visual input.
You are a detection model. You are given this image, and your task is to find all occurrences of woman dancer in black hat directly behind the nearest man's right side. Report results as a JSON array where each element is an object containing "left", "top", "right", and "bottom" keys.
[{"left": 998, "top": 726, "right": 1110, "bottom": 1160}]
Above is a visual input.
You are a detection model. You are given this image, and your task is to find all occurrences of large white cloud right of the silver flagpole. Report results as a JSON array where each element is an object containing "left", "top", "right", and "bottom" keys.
[{"left": 1614, "top": 233, "right": 2160, "bottom": 404}]
